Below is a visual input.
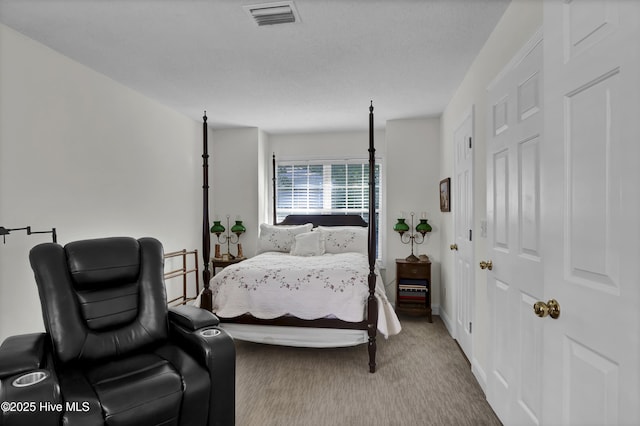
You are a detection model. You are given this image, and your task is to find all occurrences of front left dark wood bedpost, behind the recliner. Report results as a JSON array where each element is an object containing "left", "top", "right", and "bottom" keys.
[{"left": 200, "top": 111, "right": 213, "bottom": 311}]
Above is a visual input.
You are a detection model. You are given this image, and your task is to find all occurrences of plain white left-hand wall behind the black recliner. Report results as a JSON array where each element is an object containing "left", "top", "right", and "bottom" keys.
[{"left": 0, "top": 25, "right": 202, "bottom": 341}]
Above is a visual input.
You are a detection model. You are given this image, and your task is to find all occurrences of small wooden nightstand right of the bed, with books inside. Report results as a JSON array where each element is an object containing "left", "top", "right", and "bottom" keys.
[{"left": 396, "top": 259, "right": 433, "bottom": 322}]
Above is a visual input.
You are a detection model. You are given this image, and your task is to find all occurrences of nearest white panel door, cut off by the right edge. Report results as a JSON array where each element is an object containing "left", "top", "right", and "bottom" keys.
[{"left": 539, "top": 0, "right": 640, "bottom": 425}]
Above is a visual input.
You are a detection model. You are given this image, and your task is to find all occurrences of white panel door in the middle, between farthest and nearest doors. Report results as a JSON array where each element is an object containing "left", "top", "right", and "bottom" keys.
[{"left": 484, "top": 33, "right": 543, "bottom": 425}]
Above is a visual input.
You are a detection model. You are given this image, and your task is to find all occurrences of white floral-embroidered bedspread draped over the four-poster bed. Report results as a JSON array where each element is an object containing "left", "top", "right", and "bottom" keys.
[{"left": 210, "top": 252, "right": 401, "bottom": 337}]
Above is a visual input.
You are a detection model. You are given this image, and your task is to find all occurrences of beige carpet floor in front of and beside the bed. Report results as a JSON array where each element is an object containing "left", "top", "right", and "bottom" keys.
[{"left": 236, "top": 317, "right": 500, "bottom": 426}]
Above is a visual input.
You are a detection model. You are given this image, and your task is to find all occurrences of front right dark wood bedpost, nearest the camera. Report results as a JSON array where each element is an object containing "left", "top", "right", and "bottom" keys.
[{"left": 367, "top": 101, "right": 378, "bottom": 373}]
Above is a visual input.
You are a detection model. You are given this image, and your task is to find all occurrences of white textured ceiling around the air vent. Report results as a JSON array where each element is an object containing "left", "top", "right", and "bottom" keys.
[{"left": 0, "top": 0, "right": 509, "bottom": 133}]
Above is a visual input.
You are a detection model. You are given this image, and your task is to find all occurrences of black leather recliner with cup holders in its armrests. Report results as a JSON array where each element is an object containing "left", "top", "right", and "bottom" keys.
[{"left": 0, "top": 237, "right": 235, "bottom": 426}]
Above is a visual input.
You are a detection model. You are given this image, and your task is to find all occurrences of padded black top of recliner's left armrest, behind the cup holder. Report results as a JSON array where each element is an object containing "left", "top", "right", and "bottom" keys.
[{"left": 0, "top": 333, "right": 47, "bottom": 377}]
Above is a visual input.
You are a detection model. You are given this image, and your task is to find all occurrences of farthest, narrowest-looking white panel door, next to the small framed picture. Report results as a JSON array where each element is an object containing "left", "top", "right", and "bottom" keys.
[{"left": 452, "top": 108, "right": 475, "bottom": 360}]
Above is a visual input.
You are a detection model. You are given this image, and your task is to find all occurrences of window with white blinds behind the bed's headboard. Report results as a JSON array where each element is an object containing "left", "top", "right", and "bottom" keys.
[{"left": 276, "top": 160, "right": 381, "bottom": 253}]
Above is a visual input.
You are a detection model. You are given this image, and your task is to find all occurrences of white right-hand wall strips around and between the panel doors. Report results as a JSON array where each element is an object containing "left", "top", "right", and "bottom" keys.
[{"left": 440, "top": 0, "right": 542, "bottom": 384}]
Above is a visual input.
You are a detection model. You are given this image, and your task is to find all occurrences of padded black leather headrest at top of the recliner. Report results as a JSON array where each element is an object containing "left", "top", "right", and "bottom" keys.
[{"left": 64, "top": 237, "right": 140, "bottom": 290}]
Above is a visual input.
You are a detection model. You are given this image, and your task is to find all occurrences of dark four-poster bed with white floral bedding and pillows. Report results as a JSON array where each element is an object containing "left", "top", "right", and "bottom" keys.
[{"left": 199, "top": 104, "right": 400, "bottom": 373}]
